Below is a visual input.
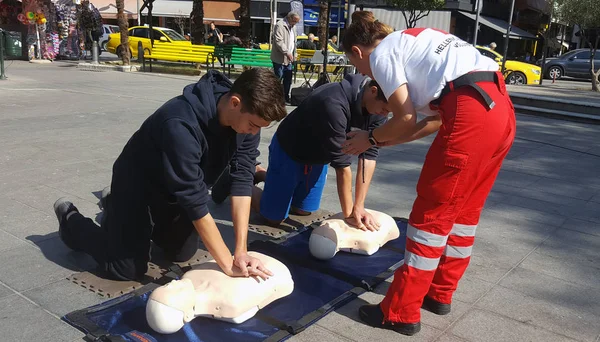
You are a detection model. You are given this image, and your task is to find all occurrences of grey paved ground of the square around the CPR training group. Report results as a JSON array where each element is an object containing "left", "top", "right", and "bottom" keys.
[{"left": 0, "top": 62, "right": 600, "bottom": 342}]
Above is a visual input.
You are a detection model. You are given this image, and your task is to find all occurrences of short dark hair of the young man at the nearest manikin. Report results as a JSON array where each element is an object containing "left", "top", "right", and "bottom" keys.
[{"left": 230, "top": 68, "right": 287, "bottom": 122}]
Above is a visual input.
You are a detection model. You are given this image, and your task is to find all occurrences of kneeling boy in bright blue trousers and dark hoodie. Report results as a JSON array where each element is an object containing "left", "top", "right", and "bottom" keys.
[{"left": 252, "top": 75, "right": 389, "bottom": 230}]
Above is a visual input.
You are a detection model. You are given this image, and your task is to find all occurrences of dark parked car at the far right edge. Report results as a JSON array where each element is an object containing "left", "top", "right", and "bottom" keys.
[{"left": 540, "top": 49, "right": 600, "bottom": 80}]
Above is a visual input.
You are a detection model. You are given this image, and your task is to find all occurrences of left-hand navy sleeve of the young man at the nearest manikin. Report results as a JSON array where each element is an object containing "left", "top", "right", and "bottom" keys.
[{"left": 160, "top": 118, "right": 208, "bottom": 221}]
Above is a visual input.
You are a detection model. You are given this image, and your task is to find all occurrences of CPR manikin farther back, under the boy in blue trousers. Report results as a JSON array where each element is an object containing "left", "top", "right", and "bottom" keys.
[{"left": 308, "top": 209, "right": 400, "bottom": 260}]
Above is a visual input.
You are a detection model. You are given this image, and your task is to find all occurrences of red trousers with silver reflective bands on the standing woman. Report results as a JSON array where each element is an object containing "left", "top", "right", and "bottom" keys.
[{"left": 380, "top": 75, "right": 516, "bottom": 323}]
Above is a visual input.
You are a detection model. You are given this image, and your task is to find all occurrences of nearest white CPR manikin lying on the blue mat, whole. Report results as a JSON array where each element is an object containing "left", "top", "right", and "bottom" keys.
[{"left": 146, "top": 252, "right": 294, "bottom": 334}]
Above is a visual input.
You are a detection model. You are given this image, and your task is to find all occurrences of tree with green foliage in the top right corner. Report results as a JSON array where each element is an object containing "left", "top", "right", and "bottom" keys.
[{"left": 554, "top": 0, "right": 600, "bottom": 91}]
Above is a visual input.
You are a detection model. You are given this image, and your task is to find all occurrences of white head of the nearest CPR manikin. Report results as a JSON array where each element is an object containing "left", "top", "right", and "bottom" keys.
[{"left": 146, "top": 279, "right": 196, "bottom": 334}]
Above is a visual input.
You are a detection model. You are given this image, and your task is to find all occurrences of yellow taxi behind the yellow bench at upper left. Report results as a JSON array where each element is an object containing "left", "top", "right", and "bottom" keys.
[{"left": 106, "top": 26, "right": 192, "bottom": 57}]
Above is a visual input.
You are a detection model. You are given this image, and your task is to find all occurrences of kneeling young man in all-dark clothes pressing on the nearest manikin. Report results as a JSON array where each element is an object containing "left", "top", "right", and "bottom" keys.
[{"left": 54, "top": 68, "right": 286, "bottom": 280}]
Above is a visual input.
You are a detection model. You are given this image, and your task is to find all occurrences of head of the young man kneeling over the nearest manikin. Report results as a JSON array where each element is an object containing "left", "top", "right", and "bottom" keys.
[{"left": 217, "top": 68, "right": 287, "bottom": 135}]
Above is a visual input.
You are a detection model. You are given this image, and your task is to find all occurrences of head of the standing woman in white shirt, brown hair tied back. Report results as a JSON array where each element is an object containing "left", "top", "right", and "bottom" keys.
[{"left": 342, "top": 11, "right": 393, "bottom": 78}]
